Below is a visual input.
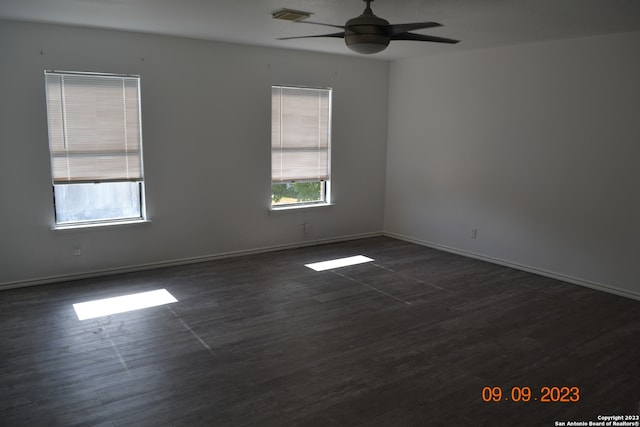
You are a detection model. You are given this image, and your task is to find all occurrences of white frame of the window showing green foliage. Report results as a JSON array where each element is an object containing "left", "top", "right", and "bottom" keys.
[{"left": 269, "top": 84, "right": 333, "bottom": 211}]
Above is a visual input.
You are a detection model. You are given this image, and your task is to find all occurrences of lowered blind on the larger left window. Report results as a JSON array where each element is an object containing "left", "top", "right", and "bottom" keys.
[{"left": 45, "top": 71, "right": 142, "bottom": 184}]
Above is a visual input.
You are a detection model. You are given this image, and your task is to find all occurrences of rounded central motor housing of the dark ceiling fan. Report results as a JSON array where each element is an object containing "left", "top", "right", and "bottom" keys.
[{"left": 344, "top": 7, "right": 391, "bottom": 54}]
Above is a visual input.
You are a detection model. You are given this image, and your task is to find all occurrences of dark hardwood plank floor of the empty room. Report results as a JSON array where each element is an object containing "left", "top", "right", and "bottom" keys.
[{"left": 0, "top": 237, "right": 640, "bottom": 426}]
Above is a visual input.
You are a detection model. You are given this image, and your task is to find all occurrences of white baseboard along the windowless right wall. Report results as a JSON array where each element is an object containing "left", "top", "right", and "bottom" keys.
[{"left": 383, "top": 231, "right": 640, "bottom": 301}]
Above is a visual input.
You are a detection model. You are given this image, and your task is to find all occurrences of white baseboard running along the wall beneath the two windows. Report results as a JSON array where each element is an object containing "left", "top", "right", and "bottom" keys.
[{"left": 0, "top": 232, "right": 383, "bottom": 290}]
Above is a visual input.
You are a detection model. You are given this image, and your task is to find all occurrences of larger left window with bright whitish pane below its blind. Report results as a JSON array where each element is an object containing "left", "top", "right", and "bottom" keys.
[{"left": 45, "top": 71, "right": 145, "bottom": 227}]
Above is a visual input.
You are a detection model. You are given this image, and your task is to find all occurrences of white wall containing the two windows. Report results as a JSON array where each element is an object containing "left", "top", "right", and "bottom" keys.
[{"left": 0, "top": 21, "right": 389, "bottom": 287}]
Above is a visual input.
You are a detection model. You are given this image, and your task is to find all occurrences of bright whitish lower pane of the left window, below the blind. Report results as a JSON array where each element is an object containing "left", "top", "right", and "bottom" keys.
[{"left": 54, "top": 182, "right": 142, "bottom": 224}]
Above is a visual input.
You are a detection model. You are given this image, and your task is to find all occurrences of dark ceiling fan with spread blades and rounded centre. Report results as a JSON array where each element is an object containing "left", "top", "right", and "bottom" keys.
[{"left": 278, "top": 0, "right": 459, "bottom": 54}]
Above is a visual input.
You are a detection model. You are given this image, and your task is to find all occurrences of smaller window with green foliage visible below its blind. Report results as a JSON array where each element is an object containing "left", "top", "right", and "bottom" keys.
[{"left": 271, "top": 86, "right": 331, "bottom": 208}]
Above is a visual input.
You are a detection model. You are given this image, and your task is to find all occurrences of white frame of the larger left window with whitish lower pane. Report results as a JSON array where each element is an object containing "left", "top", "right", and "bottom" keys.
[{"left": 44, "top": 70, "right": 149, "bottom": 230}]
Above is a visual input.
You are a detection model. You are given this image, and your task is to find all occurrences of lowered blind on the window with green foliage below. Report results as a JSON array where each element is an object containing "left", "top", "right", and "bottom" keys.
[{"left": 271, "top": 86, "right": 331, "bottom": 183}]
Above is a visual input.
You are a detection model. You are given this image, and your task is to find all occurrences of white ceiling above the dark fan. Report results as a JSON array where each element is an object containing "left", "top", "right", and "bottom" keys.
[{"left": 0, "top": 0, "right": 640, "bottom": 60}]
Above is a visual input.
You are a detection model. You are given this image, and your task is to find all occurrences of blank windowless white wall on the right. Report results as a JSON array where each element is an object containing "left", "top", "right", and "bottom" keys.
[{"left": 385, "top": 33, "right": 640, "bottom": 296}]
